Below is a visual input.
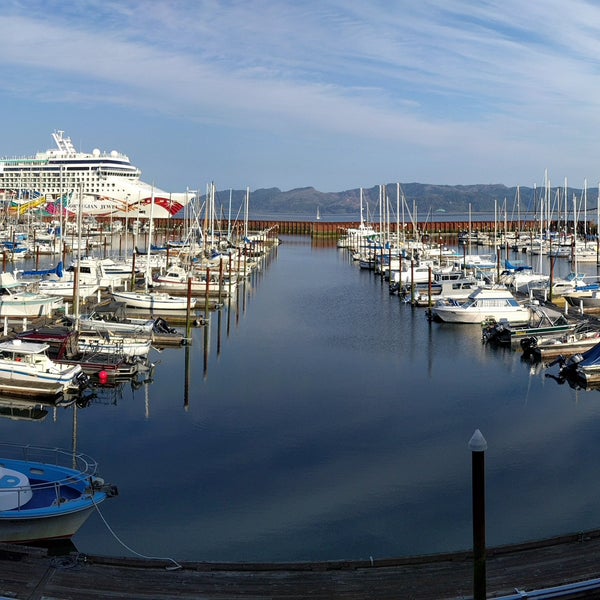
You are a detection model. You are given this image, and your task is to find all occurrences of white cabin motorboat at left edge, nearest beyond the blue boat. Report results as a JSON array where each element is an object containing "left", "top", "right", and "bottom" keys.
[{"left": 0, "top": 338, "right": 89, "bottom": 397}]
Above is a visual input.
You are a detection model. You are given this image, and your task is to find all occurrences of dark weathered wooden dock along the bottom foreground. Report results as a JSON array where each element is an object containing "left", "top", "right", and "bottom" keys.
[{"left": 5, "top": 530, "right": 600, "bottom": 600}]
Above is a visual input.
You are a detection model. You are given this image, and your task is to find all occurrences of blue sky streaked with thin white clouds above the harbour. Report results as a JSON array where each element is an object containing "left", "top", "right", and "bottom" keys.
[{"left": 0, "top": 0, "right": 600, "bottom": 192}]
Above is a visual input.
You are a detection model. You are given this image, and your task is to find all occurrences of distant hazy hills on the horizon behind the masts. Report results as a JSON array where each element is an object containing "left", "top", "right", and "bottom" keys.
[{"left": 202, "top": 183, "right": 597, "bottom": 220}]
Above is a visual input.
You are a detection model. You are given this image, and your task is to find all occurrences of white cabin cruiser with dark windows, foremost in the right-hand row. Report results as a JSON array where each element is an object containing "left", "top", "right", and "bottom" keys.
[{"left": 431, "top": 286, "right": 531, "bottom": 325}]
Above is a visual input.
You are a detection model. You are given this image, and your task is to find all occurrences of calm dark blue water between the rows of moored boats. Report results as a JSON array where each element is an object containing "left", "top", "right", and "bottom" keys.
[{"left": 5, "top": 237, "right": 600, "bottom": 561}]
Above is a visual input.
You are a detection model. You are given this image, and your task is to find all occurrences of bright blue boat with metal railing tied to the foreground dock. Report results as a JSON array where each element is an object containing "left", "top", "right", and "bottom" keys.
[{"left": 0, "top": 443, "right": 118, "bottom": 543}]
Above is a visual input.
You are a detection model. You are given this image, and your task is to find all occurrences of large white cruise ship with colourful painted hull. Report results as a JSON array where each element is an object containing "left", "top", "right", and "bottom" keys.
[{"left": 0, "top": 130, "right": 194, "bottom": 219}]
